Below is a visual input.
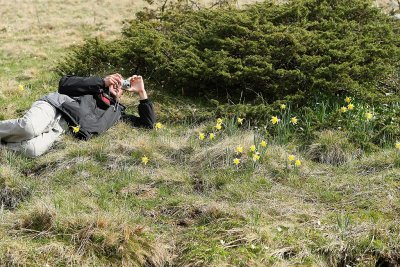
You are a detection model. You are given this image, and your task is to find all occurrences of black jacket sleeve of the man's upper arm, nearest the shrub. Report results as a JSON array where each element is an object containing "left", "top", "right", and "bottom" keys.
[{"left": 58, "top": 76, "right": 105, "bottom": 97}]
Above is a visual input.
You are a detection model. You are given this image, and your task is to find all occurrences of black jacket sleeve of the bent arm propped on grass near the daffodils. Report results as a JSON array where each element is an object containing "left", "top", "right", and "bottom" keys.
[{"left": 122, "top": 99, "right": 156, "bottom": 129}]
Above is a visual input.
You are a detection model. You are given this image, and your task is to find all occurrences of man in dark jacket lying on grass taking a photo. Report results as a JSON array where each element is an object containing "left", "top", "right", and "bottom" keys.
[{"left": 0, "top": 74, "right": 155, "bottom": 157}]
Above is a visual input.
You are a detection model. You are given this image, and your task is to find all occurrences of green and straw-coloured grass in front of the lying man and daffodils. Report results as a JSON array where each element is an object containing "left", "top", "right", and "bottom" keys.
[{"left": 0, "top": 122, "right": 400, "bottom": 266}]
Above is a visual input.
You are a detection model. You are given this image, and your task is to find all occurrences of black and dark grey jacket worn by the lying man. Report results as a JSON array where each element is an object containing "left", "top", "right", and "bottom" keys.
[{"left": 44, "top": 76, "right": 155, "bottom": 140}]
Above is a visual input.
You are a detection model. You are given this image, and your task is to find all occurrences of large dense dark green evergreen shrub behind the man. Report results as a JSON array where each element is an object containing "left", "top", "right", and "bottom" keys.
[{"left": 59, "top": 0, "right": 400, "bottom": 102}]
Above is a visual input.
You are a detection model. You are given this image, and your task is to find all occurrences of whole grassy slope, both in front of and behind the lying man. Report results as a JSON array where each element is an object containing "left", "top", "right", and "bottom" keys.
[{"left": 0, "top": 0, "right": 400, "bottom": 266}]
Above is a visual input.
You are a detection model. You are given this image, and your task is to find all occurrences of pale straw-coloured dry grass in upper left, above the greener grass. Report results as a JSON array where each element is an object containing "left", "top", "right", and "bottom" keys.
[{"left": 0, "top": 0, "right": 148, "bottom": 55}]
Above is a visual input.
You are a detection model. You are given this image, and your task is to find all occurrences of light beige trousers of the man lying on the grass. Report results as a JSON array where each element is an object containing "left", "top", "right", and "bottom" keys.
[{"left": 0, "top": 101, "right": 68, "bottom": 157}]
